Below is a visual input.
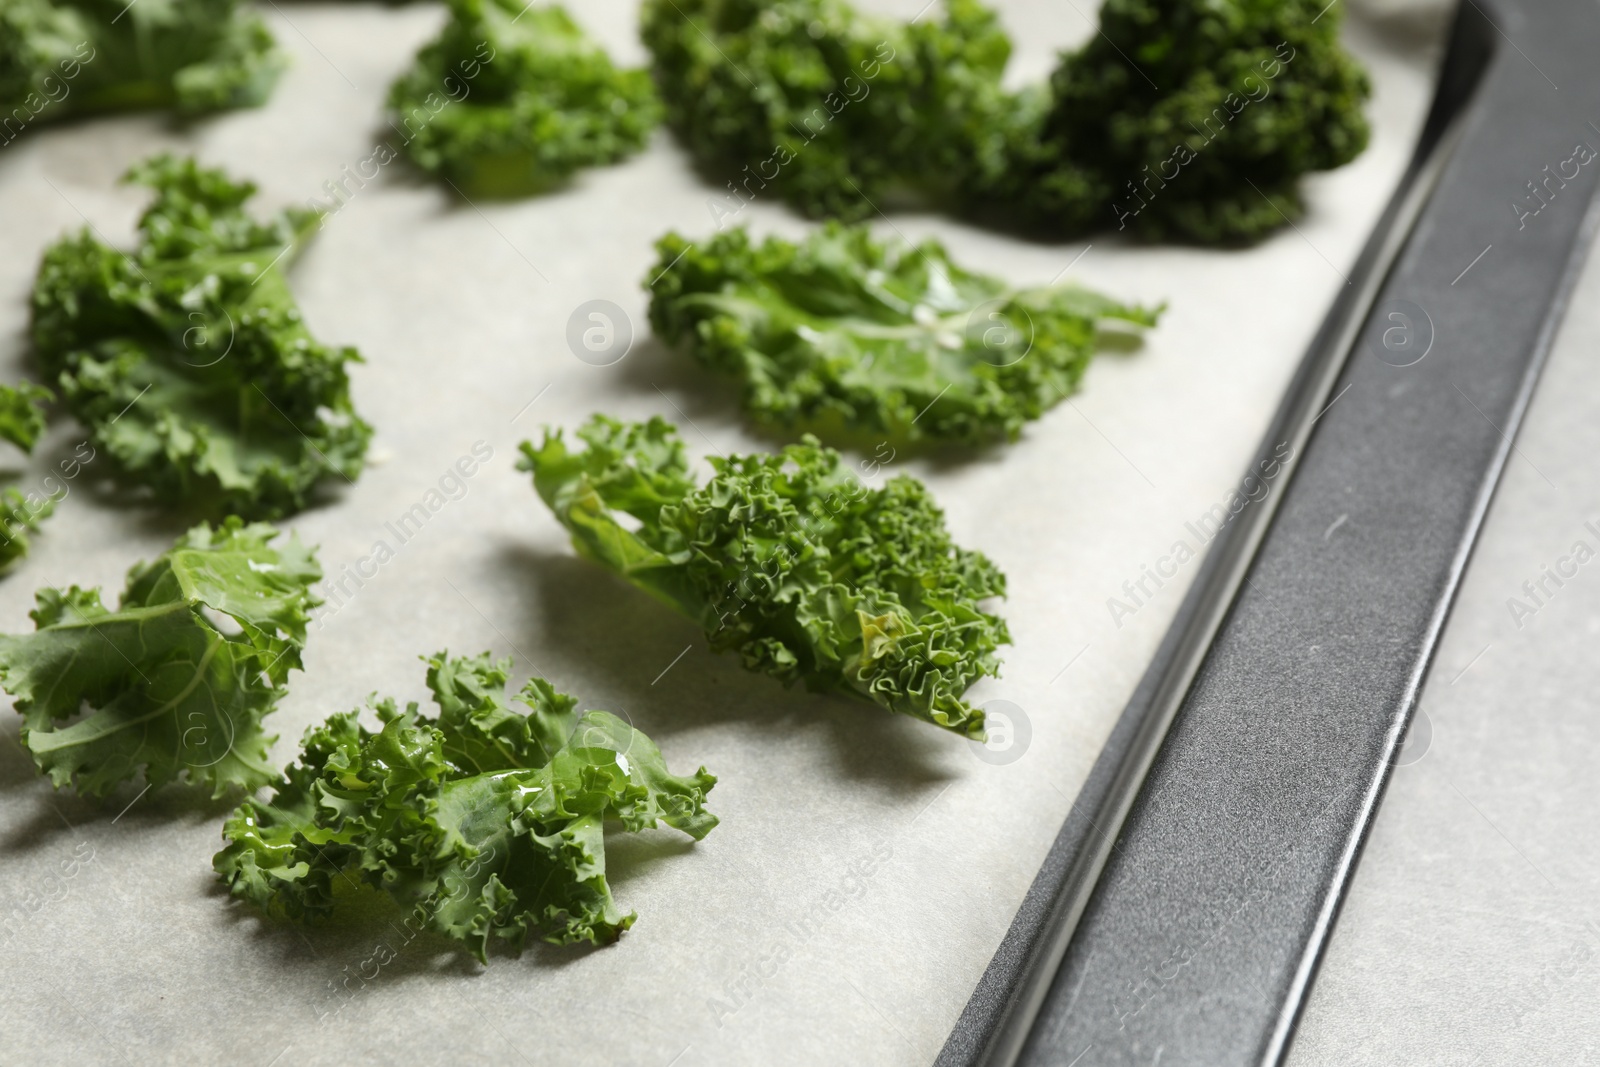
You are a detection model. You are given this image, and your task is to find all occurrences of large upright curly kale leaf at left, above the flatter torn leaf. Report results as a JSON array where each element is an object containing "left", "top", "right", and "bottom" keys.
[{"left": 32, "top": 155, "right": 371, "bottom": 518}]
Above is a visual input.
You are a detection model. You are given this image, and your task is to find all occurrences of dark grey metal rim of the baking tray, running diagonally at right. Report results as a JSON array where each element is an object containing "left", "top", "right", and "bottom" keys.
[{"left": 939, "top": 0, "right": 1600, "bottom": 1067}]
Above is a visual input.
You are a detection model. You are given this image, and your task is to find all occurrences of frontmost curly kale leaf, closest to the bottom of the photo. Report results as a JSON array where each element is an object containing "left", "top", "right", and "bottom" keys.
[{"left": 213, "top": 653, "right": 717, "bottom": 960}]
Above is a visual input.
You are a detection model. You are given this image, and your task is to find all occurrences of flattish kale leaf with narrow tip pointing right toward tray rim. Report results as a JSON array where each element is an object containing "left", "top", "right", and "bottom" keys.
[{"left": 650, "top": 224, "right": 1160, "bottom": 445}]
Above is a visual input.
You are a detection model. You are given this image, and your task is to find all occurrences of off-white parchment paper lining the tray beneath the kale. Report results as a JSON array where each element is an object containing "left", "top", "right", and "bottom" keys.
[{"left": 0, "top": 0, "right": 1432, "bottom": 1067}]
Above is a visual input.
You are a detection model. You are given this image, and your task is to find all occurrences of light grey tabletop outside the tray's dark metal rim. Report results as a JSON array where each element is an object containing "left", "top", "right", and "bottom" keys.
[{"left": 1290, "top": 150, "right": 1600, "bottom": 1067}]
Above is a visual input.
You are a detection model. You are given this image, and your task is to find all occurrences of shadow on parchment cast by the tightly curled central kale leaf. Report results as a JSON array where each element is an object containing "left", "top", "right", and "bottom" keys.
[{"left": 498, "top": 542, "right": 966, "bottom": 790}]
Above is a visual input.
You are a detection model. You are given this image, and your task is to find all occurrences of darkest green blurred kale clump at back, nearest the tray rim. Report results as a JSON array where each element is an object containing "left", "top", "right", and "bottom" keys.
[{"left": 972, "top": 0, "right": 1370, "bottom": 243}]
